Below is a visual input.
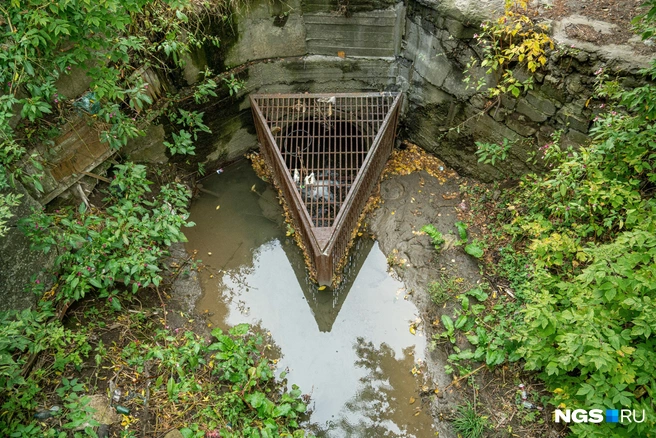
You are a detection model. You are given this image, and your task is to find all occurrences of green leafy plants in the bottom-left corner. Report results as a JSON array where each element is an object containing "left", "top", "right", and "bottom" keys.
[{"left": 0, "top": 304, "right": 93, "bottom": 437}]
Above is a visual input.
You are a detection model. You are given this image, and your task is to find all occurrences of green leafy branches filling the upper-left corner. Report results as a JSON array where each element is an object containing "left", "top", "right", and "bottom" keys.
[{"left": 0, "top": 0, "right": 243, "bottom": 220}]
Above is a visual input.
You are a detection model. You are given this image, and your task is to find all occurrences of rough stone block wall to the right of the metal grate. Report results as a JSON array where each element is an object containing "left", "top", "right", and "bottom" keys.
[{"left": 400, "top": 0, "right": 650, "bottom": 181}]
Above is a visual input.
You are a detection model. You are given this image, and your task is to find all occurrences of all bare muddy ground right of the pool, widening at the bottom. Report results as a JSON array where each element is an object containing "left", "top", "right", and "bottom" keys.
[{"left": 367, "top": 146, "right": 560, "bottom": 437}]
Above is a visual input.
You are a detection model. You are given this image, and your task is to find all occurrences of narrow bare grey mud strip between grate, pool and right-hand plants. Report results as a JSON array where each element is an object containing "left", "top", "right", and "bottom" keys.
[{"left": 368, "top": 144, "right": 481, "bottom": 436}]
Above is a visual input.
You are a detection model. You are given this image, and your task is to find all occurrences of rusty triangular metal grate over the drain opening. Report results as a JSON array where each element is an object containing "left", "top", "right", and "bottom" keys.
[{"left": 251, "top": 93, "right": 401, "bottom": 284}]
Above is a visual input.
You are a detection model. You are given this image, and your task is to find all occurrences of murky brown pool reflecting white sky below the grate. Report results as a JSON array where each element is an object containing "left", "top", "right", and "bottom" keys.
[{"left": 186, "top": 162, "right": 434, "bottom": 438}]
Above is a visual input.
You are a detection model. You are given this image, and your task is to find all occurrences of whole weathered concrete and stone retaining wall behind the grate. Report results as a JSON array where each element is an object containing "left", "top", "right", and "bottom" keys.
[{"left": 184, "top": 0, "right": 649, "bottom": 181}]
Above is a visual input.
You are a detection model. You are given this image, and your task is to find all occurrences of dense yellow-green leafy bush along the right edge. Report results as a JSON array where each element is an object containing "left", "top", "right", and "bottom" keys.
[{"left": 474, "top": 12, "right": 656, "bottom": 437}]
